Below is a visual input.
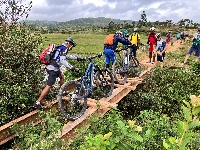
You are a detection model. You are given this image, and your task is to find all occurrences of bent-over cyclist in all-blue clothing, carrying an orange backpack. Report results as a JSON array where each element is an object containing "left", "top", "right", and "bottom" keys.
[{"left": 104, "top": 31, "right": 131, "bottom": 68}]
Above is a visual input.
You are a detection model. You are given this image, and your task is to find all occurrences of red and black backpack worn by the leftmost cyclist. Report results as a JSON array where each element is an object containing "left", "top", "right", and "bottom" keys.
[{"left": 40, "top": 44, "right": 58, "bottom": 65}]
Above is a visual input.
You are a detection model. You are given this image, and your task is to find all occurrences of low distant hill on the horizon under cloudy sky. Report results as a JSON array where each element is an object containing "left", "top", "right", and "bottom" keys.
[{"left": 21, "top": 17, "right": 133, "bottom": 27}]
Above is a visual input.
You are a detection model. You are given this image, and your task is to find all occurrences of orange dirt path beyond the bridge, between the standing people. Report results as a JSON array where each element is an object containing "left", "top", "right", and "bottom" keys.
[{"left": 140, "top": 40, "right": 181, "bottom": 67}]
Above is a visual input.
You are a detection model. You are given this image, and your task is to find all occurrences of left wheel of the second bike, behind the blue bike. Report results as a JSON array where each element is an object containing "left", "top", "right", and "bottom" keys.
[{"left": 112, "top": 61, "right": 128, "bottom": 84}]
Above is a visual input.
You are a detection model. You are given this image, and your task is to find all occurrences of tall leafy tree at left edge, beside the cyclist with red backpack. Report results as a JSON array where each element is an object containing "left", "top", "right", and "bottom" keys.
[{"left": 0, "top": 0, "right": 42, "bottom": 125}]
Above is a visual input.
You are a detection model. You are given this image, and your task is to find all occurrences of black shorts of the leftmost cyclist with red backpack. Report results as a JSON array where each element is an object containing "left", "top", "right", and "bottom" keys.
[{"left": 47, "top": 70, "right": 61, "bottom": 86}]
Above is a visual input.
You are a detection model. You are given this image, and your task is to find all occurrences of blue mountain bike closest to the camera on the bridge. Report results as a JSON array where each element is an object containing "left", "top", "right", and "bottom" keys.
[{"left": 58, "top": 54, "right": 114, "bottom": 120}]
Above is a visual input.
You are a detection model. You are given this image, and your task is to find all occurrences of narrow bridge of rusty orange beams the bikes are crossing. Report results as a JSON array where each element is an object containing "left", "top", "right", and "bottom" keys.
[{"left": 0, "top": 68, "right": 151, "bottom": 145}]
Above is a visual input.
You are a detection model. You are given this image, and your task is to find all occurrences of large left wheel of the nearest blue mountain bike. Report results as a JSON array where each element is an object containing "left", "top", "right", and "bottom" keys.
[{"left": 58, "top": 81, "right": 87, "bottom": 120}]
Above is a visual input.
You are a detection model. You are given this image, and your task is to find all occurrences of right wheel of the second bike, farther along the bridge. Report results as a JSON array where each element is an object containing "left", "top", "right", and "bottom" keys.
[{"left": 129, "top": 56, "right": 142, "bottom": 77}]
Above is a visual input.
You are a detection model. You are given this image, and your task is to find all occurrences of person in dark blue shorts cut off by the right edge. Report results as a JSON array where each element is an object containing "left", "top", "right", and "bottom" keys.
[{"left": 183, "top": 27, "right": 200, "bottom": 64}]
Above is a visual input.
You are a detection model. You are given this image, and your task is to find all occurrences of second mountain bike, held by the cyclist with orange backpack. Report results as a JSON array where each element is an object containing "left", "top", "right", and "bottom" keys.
[{"left": 112, "top": 48, "right": 142, "bottom": 84}]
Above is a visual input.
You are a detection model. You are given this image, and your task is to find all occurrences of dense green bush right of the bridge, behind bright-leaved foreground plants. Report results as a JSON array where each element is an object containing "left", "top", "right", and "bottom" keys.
[{"left": 119, "top": 68, "right": 200, "bottom": 117}]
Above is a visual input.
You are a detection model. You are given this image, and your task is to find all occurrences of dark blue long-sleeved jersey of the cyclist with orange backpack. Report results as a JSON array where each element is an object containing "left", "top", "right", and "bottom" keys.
[{"left": 104, "top": 34, "right": 131, "bottom": 50}]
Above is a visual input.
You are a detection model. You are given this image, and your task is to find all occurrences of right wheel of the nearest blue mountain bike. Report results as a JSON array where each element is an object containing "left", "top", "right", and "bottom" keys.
[{"left": 94, "top": 69, "right": 114, "bottom": 97}]
